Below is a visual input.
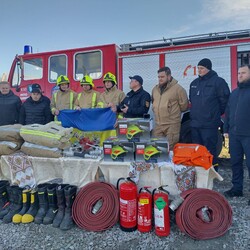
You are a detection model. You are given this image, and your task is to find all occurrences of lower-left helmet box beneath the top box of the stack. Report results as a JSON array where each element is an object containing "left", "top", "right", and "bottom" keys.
[{"left": 103, "top": 138, "right": 135, "bottom": 162}]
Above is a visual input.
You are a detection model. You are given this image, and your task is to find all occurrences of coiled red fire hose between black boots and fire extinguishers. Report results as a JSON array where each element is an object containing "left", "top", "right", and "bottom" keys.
[{"left": 72, "top": 182, "right": 119, "bottom": 232}]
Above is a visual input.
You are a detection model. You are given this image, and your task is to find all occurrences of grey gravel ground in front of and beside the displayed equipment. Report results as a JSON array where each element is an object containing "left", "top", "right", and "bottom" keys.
[{"left": 0, "top": 159, "right": 250, "bottom": 250}]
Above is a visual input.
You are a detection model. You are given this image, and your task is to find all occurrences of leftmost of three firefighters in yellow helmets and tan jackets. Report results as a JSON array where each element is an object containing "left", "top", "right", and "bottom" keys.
[{"left": 50, "top": 75, "right": 77, "bottom": 116}]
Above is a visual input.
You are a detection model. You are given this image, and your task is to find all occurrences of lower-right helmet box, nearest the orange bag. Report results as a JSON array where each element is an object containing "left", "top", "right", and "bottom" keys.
[{"left": 135, "top": 138, "right": 169, "bottom": 163}]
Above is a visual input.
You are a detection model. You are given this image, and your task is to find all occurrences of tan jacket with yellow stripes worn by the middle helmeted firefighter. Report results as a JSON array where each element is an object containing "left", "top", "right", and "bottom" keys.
[{"left": 75, "top": 89, "right": 100, "bottom": 109}]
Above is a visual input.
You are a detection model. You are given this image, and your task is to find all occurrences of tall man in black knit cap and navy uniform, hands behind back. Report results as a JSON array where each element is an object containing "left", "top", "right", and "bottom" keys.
[{"left": 189, "top": 58, "right": 230, "bottom": 170}]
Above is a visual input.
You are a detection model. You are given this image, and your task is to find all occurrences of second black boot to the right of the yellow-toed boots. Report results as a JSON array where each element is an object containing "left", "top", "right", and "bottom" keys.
[{"left": 43, "top": 183, "right": 58, "bottom": 225}]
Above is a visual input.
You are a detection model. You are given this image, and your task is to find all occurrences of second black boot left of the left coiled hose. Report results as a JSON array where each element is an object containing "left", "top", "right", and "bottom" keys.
[{"left": 53, "top": 184, "right": 69, "bottom": 227}]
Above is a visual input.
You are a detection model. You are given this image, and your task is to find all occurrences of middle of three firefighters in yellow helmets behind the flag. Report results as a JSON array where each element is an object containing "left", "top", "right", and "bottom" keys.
[{"left": 75, "top": 75, "right": 100, "bottom": 110}]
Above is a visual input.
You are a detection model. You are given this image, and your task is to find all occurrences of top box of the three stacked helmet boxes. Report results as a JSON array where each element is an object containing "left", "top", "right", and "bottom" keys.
[{"left": 117, "top": 118, "right": 153, "bottom": 142}]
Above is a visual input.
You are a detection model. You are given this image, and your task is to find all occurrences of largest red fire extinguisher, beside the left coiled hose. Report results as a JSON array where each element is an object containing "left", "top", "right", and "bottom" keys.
[{"left": 117, "top": 177, "right": 137, "bottom": 232}]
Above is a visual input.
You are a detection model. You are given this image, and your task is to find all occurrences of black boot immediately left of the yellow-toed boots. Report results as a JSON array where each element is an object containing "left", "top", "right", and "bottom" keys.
[{"left": 3, "top": 186, "right": 23, "bottom": 223}]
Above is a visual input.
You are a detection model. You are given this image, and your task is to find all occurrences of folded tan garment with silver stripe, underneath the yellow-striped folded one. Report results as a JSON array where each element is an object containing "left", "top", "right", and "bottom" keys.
[{"left": 21, "top": 142, "right": 62, "bottom": 158}]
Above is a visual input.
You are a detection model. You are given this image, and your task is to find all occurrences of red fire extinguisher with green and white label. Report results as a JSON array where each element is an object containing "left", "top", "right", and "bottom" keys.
[{"left": 153, "top": 186, "right": 170, "bottom": 236}]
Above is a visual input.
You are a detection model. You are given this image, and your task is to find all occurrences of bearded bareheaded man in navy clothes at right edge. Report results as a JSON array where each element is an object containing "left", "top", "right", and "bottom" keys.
[{"left": 224, "top": 65, "right": 250, "bottom": 201}]
